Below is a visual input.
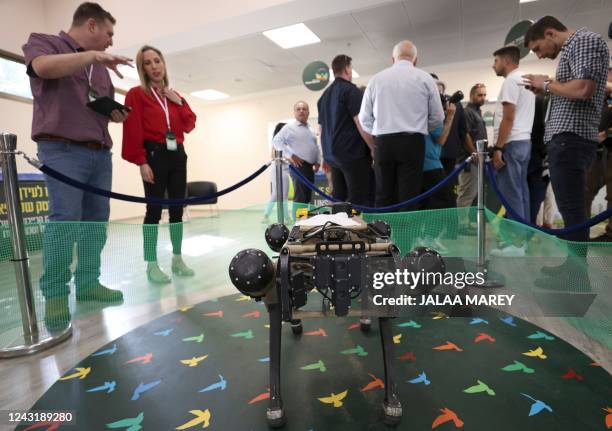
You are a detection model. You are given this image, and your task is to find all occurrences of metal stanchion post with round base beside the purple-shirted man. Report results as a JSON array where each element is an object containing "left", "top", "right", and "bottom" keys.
[{"left": 0, "top": 133, "right": 72, "bottom": 358}]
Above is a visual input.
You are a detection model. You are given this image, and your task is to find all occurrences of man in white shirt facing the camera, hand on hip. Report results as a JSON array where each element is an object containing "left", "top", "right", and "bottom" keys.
[{"left": 272, "top": 101, "right": 321, "bottom": 204}]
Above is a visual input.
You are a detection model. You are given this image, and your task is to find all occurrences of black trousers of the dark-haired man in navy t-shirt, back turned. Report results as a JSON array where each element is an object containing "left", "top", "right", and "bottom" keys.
[{"left": 331, "top": 157, "right": 373, "bottom": 206}]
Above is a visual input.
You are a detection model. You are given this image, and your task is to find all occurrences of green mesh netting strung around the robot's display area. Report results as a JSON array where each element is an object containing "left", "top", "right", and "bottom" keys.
[{"left": 0, "top": 204, "right": 612, "bottom": 347}]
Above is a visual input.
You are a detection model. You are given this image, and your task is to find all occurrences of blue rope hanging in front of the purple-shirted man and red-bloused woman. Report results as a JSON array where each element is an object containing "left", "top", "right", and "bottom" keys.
[{"left": 35, "top": 160, "right": 270, "bottom": 206}]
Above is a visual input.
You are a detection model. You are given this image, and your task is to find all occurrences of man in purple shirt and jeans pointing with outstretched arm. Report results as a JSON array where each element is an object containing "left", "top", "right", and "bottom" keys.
[{"left": 23, "top": 3, "right": 130, "bottom": 330}]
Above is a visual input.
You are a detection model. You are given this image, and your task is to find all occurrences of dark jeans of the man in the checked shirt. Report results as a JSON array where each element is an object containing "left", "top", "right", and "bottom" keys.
[{"left": 546, "top": 132, "right": 597, "bottom": 242}]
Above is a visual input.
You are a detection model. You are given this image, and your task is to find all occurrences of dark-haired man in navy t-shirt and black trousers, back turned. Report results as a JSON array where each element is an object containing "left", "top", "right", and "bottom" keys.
[{"left": 317, "top": 55, "right": 374, "bottom": 205}]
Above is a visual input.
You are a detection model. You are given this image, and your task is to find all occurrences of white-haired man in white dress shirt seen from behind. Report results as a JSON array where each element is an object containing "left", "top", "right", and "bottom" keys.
[{"left": 359, "top": 40, "right": 444, "bottom": 210}]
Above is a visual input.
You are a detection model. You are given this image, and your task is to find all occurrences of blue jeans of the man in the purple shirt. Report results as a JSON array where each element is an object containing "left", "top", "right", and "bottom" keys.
[{"left": 38, "top": 141, "right": 113, "bottom": 298}]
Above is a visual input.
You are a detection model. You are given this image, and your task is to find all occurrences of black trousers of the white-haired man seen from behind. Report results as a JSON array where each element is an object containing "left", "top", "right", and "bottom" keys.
[{"left": 374, "top": 133, "right": 425, "bottom": 211}]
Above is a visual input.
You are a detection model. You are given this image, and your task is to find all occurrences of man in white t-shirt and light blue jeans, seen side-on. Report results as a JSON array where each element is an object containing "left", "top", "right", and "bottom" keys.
[{"left": 491, "top": 46, "right": 535, "bottom": 256}]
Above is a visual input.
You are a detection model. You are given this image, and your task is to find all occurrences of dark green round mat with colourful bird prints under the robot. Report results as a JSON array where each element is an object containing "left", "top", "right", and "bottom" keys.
[{"left": 17, "top": 295, "right": 612, "bottom": 431}]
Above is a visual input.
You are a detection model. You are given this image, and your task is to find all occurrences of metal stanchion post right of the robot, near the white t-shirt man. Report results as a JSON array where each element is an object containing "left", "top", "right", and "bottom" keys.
[{"left": 476, "top": 139, "right": 503, "bottom": 287}]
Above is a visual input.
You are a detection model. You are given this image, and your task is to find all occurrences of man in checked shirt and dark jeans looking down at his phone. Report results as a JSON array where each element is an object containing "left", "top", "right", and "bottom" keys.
[{"left": 524, "top": 16, "right": 610, "bottom": 284}]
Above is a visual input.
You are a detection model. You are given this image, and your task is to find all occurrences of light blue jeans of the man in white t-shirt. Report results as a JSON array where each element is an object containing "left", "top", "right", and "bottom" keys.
[{"left": 497, "top": 140, "right": 531, "bottom": 220}]
